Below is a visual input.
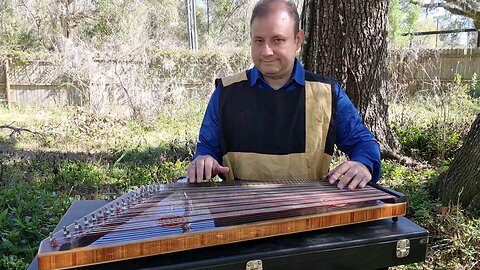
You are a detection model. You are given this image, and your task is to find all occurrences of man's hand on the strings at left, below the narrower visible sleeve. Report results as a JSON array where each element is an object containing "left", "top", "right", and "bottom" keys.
[{"left": 187, "top": 155, "right": 230, "bottom": 183}]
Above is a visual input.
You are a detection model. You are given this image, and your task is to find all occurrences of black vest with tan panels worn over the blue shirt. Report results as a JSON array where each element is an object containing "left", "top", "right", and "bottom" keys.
[{"left": 217, "top": 70, "right": 336, "bottom": 180}]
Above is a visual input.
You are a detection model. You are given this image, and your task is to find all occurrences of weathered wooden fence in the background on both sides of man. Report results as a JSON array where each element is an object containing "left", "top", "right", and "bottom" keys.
[{"left": 0, "top": 48, "right": 480, "bottom": 106}]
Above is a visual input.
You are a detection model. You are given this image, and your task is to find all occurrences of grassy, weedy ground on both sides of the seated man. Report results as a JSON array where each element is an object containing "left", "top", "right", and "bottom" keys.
[{"left": 0, "top": 88, "right": 480, "bottom": 269}]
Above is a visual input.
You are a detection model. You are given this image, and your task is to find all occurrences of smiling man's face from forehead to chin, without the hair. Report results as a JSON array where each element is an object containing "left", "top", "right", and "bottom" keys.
[{"left": 251, "top": 10, "right": 303, "bottom": 82}]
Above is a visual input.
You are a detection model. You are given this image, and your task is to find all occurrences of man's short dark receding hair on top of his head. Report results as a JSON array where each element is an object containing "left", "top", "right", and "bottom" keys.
[{"left": 250, "top": 0, "right": 300, "bottom": 35}]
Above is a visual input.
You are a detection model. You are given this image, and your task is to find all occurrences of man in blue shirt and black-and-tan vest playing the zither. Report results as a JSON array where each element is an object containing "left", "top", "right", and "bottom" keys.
[{"left": 187, "top": 0, "right": 380, "bottom": 189}]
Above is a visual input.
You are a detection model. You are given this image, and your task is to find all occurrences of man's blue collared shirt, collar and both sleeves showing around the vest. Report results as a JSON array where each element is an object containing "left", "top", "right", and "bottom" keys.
[{"left": 194, "top": 59, "right": 381, "bottom": 182}]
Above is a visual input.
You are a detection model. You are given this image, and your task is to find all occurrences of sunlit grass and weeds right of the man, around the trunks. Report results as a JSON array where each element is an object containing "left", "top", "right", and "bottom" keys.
[{"left": 382, "top": 88, "right": 480, "bottom": 269}]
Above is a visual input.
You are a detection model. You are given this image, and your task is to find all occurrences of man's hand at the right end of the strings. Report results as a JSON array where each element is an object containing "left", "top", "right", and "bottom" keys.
[{"left": 326, "top": 160, "right": 372, "bottom": 190}]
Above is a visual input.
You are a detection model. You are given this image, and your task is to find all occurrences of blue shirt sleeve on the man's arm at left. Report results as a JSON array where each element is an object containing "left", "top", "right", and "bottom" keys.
[{"left": 193, "top": 87, "right": 222, "bottom": 164}]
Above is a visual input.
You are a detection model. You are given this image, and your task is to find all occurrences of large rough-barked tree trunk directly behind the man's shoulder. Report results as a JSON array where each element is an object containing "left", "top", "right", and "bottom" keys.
[{"left": 302, "top": 0, "right": 399, "bottom": 157}]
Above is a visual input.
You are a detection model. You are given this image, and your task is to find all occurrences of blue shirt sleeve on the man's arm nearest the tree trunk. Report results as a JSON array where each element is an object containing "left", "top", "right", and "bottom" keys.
[{"left": 335, "top": 83, "right": 381, "bottom": 183}]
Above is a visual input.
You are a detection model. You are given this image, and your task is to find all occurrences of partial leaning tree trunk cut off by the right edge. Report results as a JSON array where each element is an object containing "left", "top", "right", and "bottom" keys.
[{"left": 438, "top": 114, "right": 480, "bottom": 210}]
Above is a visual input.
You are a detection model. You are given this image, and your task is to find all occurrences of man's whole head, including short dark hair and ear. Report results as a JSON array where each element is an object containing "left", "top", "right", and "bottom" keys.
[{"left": 250, "top": 0, "right": 303, "bottom": 86}]
